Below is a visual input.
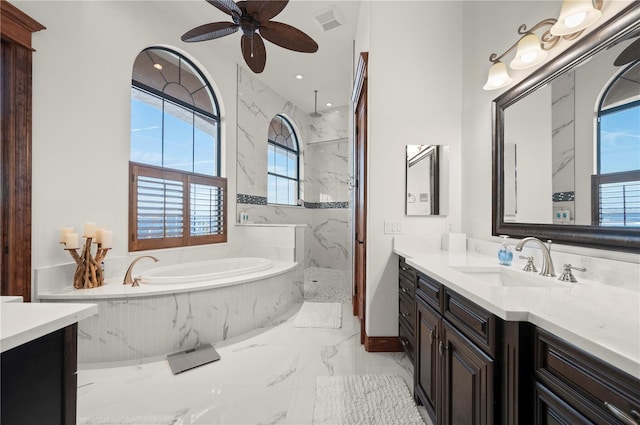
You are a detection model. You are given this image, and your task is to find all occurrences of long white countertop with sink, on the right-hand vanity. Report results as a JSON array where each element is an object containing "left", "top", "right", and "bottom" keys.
[{"left": 394, "top": 243, "right": 640, "bottom": 378}]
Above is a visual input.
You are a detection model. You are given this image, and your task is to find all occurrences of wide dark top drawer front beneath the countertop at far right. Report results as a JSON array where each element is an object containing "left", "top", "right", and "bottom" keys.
[{"left": 535, "top": 329, "right": 640, "bottom": 424}]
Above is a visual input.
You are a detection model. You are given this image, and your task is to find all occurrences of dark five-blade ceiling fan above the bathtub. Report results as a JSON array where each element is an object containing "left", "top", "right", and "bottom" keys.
[{"left": 181, "top": 0, "right": 318, "bottom": 74}]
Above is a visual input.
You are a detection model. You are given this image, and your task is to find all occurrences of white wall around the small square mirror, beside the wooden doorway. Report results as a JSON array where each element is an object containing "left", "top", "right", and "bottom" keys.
[{"left": 356, "top": 1, "right": 462, "bottom": 336}]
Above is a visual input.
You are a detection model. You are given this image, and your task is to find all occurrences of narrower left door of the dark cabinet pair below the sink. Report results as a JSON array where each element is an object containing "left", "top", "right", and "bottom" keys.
[{"left": 414, "top": 299, "right": 442, "bottom": 423}]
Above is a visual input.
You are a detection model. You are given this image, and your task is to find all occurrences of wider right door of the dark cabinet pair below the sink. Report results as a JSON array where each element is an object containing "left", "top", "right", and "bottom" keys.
[{"left": 439, "top": 320, "right": 495, "bottom": 425}]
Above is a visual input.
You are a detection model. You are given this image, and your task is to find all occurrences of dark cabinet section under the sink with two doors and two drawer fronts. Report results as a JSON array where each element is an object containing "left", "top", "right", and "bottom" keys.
[{"left": 414, "top": 273, "right": 497, "bottom": 425}]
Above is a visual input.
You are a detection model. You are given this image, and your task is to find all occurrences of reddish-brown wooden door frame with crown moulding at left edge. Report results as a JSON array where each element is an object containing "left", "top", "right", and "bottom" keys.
[{"left": 0, "top": 0, "right": 45, "bottom": 301}]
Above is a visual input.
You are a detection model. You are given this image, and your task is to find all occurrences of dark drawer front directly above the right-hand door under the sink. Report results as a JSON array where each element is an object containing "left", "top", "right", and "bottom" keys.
[{"left": 444, "top": 289, "right": 497, "bottom": 358}]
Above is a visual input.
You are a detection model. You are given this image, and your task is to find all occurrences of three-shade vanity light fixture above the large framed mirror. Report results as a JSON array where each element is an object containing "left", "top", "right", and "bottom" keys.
[{"left": 482, "top": 0, "right": 603, "bottom": 90}]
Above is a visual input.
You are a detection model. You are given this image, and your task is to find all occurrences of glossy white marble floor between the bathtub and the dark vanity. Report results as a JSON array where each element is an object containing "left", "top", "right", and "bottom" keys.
[{"left": 78, "top": 304, "right": 413, "bottom": 425}]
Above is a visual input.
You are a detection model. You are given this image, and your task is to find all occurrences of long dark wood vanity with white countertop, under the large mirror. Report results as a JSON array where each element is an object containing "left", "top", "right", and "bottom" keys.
[{"left": 394, "top": 242, "right": 640, "bottom": 424}]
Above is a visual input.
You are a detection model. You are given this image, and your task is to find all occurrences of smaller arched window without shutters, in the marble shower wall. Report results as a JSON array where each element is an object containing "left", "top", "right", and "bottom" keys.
[{"left": 267, "top": 115, "right": 300, "bottom": 205}]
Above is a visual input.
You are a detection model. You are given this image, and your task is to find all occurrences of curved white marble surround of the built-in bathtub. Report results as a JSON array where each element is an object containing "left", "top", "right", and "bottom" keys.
[{"left": 42, "top": 262, "right": 302, "bottom": 364}]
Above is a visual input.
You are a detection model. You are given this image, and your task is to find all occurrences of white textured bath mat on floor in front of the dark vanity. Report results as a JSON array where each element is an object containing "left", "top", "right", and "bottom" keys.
[{"left": 313, "top": 375, "right": 424, "bottom": 425}]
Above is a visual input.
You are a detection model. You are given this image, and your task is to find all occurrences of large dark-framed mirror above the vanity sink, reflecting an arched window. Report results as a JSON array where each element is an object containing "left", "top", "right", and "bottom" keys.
[{"left": 492, "top": 2, "right": 640, "bottom": 251}]
